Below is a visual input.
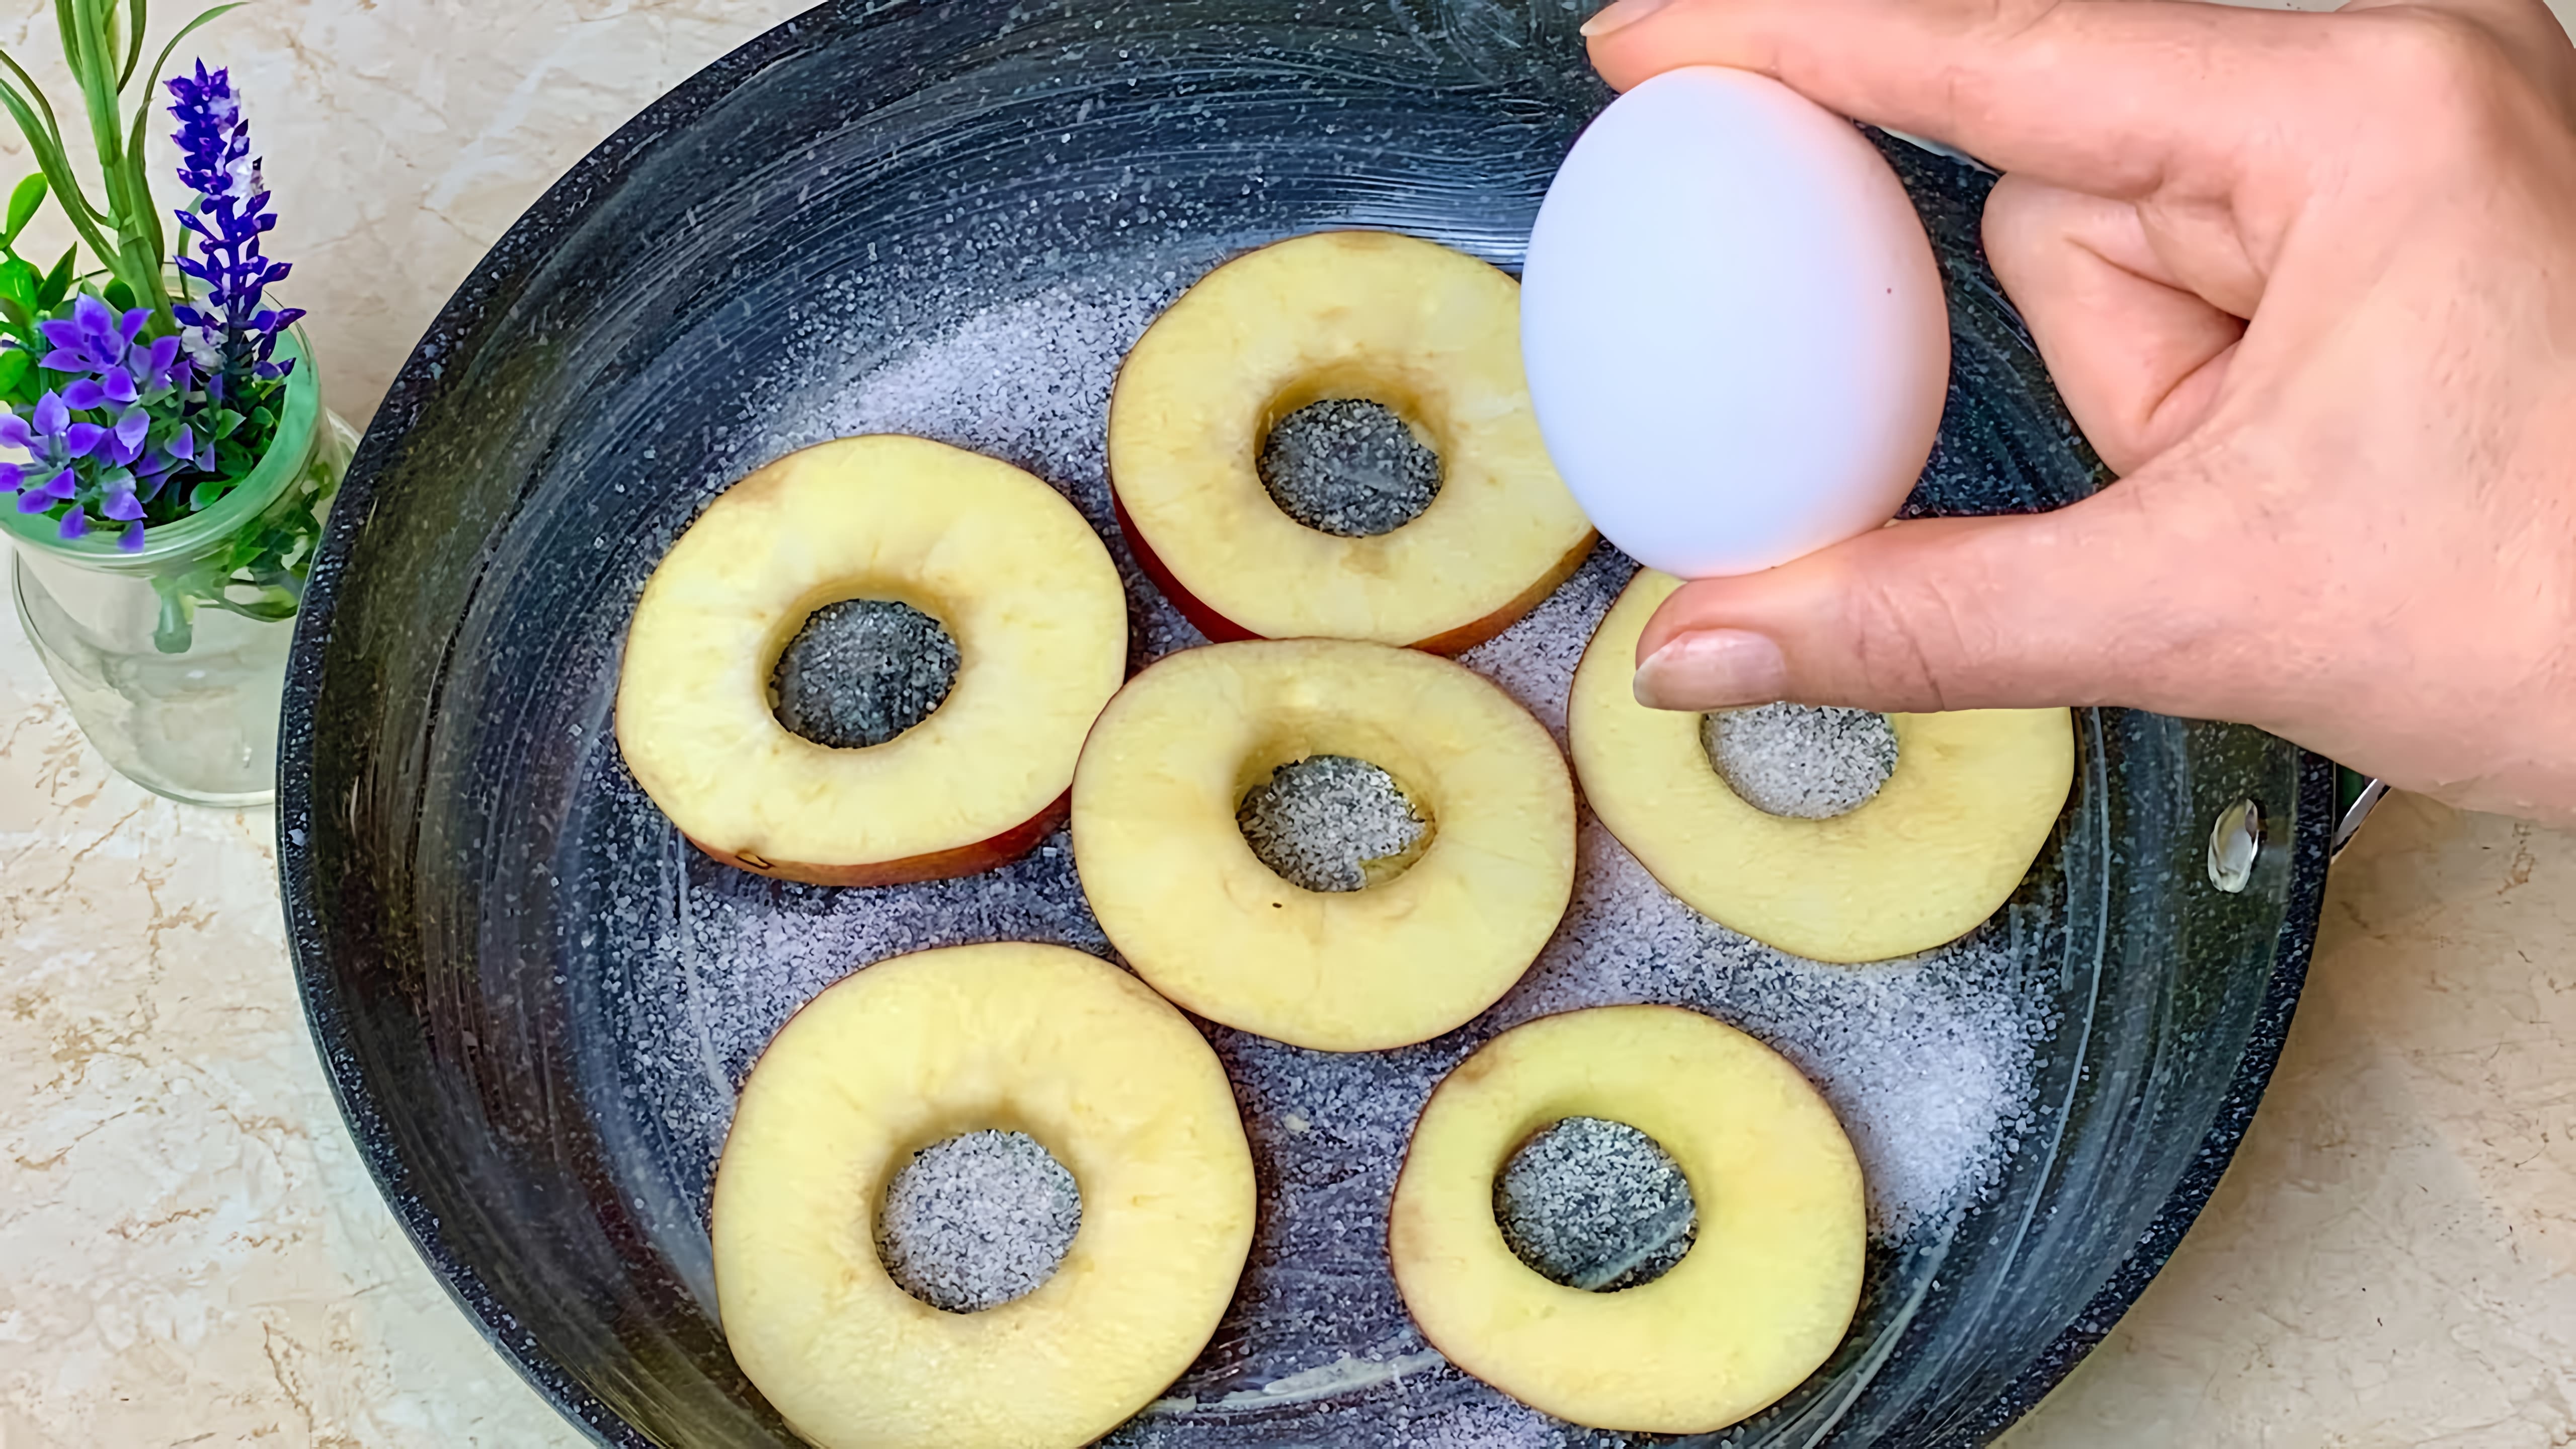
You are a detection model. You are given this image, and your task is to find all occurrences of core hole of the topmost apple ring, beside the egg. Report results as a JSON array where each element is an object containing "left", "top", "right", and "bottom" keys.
[{"left": 1260, "top": 397, "right": 1440, "bottom": 539}]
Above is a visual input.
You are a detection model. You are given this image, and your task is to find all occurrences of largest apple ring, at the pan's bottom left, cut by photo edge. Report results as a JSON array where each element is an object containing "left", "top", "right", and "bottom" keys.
[{"left": 713, "top": 944, "right": 1254, "bottom": 1449}]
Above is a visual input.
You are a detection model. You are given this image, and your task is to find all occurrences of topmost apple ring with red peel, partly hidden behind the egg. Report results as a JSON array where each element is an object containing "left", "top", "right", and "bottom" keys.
[{"left": 1110, "top": 232, "right": 1592, "bottom": 655}]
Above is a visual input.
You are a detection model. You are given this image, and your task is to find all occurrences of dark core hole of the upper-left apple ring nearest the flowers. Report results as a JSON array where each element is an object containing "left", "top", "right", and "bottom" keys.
[{"left": 770, "top": 598, "right": 958, "bottom": 750}]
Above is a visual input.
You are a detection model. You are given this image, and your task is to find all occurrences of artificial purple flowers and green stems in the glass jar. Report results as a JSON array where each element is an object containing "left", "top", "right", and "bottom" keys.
[{"left": 0, "top": 0, "right": 322, "bottom": 650}]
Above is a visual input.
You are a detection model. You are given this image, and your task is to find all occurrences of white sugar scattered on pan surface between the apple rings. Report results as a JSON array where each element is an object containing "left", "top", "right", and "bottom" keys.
[{"left": 608, "top": 276, "right": 2051, "bottom": 1446}]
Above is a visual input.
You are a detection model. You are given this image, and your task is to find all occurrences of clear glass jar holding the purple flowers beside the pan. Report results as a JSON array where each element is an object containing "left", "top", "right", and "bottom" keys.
[{"left": 0, "top": 322, "right": 358, "bottom": 807}]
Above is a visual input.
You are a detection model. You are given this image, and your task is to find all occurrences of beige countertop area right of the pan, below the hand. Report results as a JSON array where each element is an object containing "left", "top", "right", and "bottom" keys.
[{"left": 2006, "top": 796, "right": 2576, "bottom": 1449}]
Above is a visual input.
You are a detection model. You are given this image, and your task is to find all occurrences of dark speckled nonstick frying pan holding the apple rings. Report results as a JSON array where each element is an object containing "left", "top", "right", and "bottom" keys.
[{"left": 278, "top": 0, "right": 2337, "bottom": 1449}]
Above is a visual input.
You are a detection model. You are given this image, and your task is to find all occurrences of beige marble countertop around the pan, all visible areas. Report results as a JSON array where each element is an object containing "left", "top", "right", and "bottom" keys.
[{"left": 0, "top": 0, "right": 2576, "bottom": 1449}]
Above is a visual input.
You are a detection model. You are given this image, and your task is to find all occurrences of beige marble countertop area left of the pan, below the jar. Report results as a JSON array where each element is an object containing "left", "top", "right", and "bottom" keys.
[{"left": 0, "top": 645, "right": 582, "bottom": 1449}]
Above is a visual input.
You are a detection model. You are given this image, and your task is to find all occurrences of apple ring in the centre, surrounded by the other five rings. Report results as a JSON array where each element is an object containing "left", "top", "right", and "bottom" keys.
[{"left": 1074, "top": 639, "right": 1574, "bottom": 1052}]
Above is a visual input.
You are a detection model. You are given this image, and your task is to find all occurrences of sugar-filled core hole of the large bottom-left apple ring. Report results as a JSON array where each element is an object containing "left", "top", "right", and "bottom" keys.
[{"left": 876, "top": 1130, "right": 1082, "bottom": 1312}]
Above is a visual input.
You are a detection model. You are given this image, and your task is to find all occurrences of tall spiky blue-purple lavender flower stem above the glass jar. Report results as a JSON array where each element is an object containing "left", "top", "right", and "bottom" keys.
[{"left": 170, "top": 62, "right": 304, "bottom": 413}]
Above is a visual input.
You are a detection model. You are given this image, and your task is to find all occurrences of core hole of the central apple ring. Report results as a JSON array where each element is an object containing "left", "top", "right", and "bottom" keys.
[{"left": 1234, "top": 755, "right": 1432, "bottom": 892}]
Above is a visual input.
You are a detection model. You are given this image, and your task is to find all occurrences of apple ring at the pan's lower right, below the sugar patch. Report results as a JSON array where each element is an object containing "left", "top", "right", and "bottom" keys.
[{"left": 1386, "top": 1006, "right": 1868, "bottom": 1433}]
